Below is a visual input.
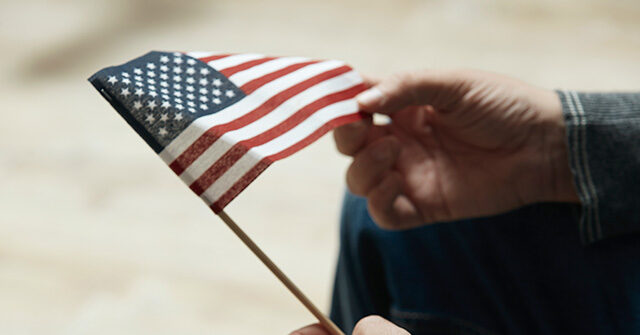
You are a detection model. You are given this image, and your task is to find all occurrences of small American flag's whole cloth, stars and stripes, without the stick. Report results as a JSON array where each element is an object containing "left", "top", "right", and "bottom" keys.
[{"left": 89, "top": 51, "right": 365, "bottom": 213}]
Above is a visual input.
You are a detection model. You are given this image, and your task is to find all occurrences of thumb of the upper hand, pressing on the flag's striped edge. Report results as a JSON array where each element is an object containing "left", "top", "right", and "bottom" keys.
[{"left": 356, "top": 70, "right": 464, "bottom": 115}]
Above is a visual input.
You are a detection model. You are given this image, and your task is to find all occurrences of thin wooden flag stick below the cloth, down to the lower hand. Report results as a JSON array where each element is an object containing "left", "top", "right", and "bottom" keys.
[{"left": 218, "top": 211, "right": 344, "bottom": 335}]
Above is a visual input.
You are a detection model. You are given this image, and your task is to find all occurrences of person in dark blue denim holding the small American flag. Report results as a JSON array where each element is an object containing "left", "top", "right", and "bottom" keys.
[{"left": 294, "top": 70, "right": 640, "bottom": 335}]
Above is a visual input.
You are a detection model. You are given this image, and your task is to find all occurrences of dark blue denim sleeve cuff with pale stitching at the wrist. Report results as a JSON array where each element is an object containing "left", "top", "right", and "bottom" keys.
[{"left": 557, "top": 91, "right": 640, "bottom": 244}]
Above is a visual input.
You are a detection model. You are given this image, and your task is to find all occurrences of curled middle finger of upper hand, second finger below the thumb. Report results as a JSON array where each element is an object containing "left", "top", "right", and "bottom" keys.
[{"left": 347, "top": 136, "right": 400, "bottom": 196}]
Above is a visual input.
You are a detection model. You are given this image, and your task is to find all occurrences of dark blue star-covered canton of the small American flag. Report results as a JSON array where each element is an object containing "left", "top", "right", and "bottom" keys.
[{"left": 89, "top": 51, "right": 245, "bottom": 152}]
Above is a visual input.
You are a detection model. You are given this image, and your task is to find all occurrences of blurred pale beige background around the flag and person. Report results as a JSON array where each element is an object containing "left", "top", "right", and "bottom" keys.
[{"left": 0, "top": 0, "right": 640, "bottom": 335}]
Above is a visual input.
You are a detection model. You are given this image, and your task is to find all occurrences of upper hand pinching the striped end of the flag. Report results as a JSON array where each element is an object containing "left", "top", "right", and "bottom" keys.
[{"left": 334, "top": 70, "right": 578, "bottom": 228}]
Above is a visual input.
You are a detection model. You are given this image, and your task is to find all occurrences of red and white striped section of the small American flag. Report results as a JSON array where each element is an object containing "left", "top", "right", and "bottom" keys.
[{"left": 160, "top": 52, "right": 365, "bottom": 213}]
